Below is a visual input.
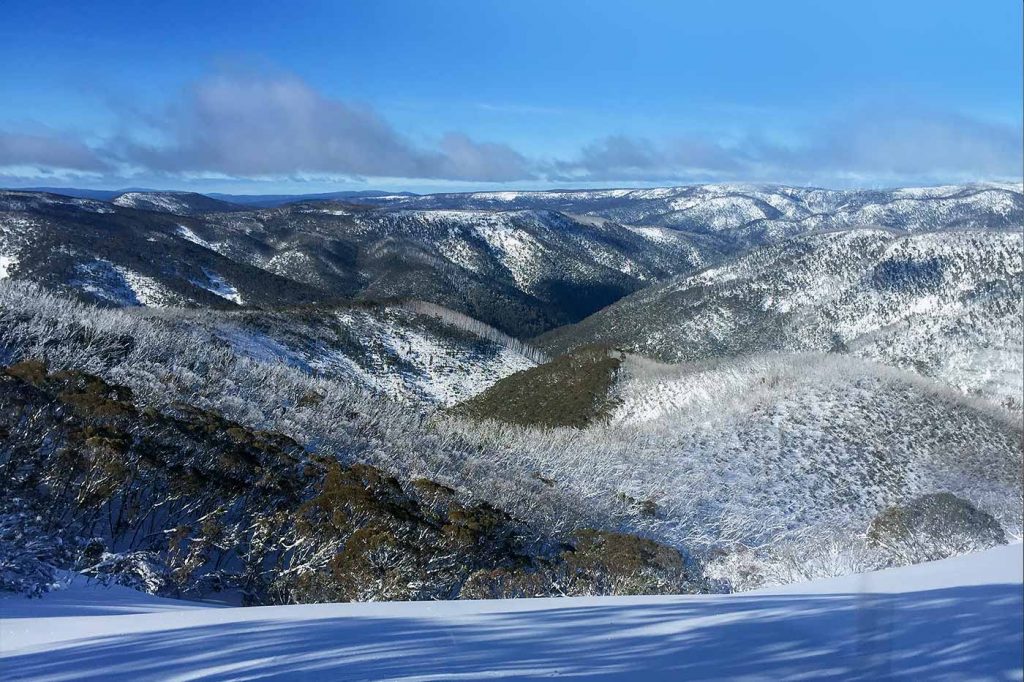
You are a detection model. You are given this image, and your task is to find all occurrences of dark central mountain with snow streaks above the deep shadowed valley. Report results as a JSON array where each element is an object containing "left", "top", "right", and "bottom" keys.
[{"left": 208, "top": 203, "right": 720, "bottom": 336}]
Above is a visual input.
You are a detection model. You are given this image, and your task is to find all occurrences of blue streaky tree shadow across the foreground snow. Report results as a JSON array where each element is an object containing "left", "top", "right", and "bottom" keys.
[{"left": 0, "top": 585, "right": 1024, "bottom": 681}]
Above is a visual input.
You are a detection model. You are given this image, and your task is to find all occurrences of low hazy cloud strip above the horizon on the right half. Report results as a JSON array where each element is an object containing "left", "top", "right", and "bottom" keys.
[{"left": 549, "top": 111, "right": 1024, "bottom": 183}]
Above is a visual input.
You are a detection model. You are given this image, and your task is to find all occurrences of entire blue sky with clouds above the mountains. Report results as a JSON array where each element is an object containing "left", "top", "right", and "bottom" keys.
[{"left": 0, "top": 0, "right": 1024, "bottom": 193}]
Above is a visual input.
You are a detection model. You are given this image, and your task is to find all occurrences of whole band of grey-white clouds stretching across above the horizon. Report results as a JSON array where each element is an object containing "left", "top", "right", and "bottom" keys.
[{"left": 0, "top": 74, "right": 1024, "bottom": 184}]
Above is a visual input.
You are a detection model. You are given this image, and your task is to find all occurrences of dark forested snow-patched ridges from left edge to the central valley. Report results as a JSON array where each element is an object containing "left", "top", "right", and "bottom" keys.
[{"left": 0, "top": 193, "right": 720, "bottom": 336}]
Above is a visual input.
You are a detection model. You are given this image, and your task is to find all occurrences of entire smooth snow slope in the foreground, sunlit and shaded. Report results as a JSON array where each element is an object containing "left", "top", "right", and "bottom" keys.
[{"left": 0, "top": 544, "right": 1024, "bottom": 680}]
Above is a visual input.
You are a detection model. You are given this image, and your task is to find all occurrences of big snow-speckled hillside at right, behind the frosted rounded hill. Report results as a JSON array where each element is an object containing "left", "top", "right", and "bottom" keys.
[{"left": 540, "top": 229, "right": 1024, "bottom": 410}]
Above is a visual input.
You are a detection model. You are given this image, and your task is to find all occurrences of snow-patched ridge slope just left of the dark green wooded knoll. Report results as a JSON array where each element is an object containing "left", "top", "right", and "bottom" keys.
[{"left": 147, "top": 304, "right": 540, "bottom": 406}]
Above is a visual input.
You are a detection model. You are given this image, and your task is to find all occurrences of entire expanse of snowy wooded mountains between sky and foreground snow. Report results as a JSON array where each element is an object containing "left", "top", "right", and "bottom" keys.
[{"left": 0, "top": 179, "right": 1024, "bottom": 603}]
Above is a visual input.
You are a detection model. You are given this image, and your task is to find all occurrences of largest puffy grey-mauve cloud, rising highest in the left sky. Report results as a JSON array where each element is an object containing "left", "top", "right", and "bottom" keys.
[{"left": 118, "top": 75, "right": 531, "bottom": 181}]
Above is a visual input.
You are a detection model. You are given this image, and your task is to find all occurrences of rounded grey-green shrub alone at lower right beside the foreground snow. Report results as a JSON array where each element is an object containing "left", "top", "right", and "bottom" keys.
[{"left": 867, "top": 493, "right": 1007, "bottom": 564}]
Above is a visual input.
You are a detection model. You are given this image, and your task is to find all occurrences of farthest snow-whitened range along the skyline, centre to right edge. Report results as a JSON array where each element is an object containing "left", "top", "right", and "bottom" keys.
[{"left": 369, "top": 184, "right": 1024, "bottom": 242}]
